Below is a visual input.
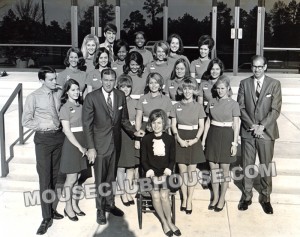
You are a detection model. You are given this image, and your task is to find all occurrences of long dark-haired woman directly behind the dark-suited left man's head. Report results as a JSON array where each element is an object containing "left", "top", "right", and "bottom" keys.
[{"left": 86, "top": 47, "right": 110, "bottom": 93}]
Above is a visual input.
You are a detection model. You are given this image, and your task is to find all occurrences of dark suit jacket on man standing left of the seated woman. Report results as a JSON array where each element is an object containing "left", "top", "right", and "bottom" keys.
[{"left": 82, "top": 87, "right": 136, "bottom": 157}]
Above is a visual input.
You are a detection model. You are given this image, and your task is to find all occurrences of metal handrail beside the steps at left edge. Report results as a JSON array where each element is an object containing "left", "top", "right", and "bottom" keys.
[{"left": 0, "top": 83, "right": 24, "bottom": 177}]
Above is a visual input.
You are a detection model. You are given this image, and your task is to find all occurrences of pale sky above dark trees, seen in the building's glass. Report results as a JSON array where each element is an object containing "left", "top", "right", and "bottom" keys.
[{"left": 0, "top": 0, "right": 299, "bottom": 26}]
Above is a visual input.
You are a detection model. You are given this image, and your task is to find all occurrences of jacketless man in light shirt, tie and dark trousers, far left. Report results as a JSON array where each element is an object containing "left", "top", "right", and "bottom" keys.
[{"left": 22, "top": 66, "right": 65, "bottom": 235}]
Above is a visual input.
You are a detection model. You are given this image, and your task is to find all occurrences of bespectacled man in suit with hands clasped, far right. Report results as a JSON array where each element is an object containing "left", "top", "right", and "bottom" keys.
[{"left": 237, "top": 55, "right": 282, "bottom": 214}]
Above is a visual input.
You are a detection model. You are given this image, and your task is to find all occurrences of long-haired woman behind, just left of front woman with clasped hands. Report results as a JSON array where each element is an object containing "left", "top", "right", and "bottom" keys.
[{"left": 164, "top": 58, "right": 190, "bottom": 104}]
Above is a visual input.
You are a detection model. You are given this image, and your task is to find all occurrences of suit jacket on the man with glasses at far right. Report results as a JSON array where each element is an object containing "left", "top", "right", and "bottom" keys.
[{"left": 237, "top": 76, "right": 282, "bottom": 140}]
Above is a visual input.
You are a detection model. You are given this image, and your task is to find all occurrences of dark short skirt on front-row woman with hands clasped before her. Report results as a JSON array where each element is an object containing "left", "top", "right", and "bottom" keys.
[{"left": 176, "top": 129, "right": 205, "bottom": 165}]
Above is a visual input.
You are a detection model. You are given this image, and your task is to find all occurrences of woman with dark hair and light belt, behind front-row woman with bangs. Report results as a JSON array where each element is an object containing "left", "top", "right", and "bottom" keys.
[{"left": 124, "top": 51, "right": 147, "bottom": 100}]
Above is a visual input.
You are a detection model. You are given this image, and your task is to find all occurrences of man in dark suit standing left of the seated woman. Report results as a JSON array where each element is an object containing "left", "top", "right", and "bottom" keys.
[{"left": 82, "top": 69, "right": 144, "bottom": 225}]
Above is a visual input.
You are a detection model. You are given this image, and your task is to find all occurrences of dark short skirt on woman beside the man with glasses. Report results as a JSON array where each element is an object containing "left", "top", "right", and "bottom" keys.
[{"left": 205, "top": 124, "right": 236, "bottom": 164}]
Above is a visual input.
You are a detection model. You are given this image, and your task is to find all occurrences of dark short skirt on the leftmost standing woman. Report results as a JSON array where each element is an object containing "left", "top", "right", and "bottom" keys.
[{"left": 60, "top": 132, "right": 87, "bottom": 174}]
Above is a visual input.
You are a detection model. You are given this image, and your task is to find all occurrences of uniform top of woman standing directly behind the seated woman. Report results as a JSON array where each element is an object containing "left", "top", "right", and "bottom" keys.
[{"left": 136, "top": 92, "right": 172, "bottom": 129}]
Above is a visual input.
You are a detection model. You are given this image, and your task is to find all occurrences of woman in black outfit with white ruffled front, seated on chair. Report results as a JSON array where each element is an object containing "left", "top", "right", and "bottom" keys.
[{"left": 141, "top": 109, "right": 181, "bottom": 236}]
